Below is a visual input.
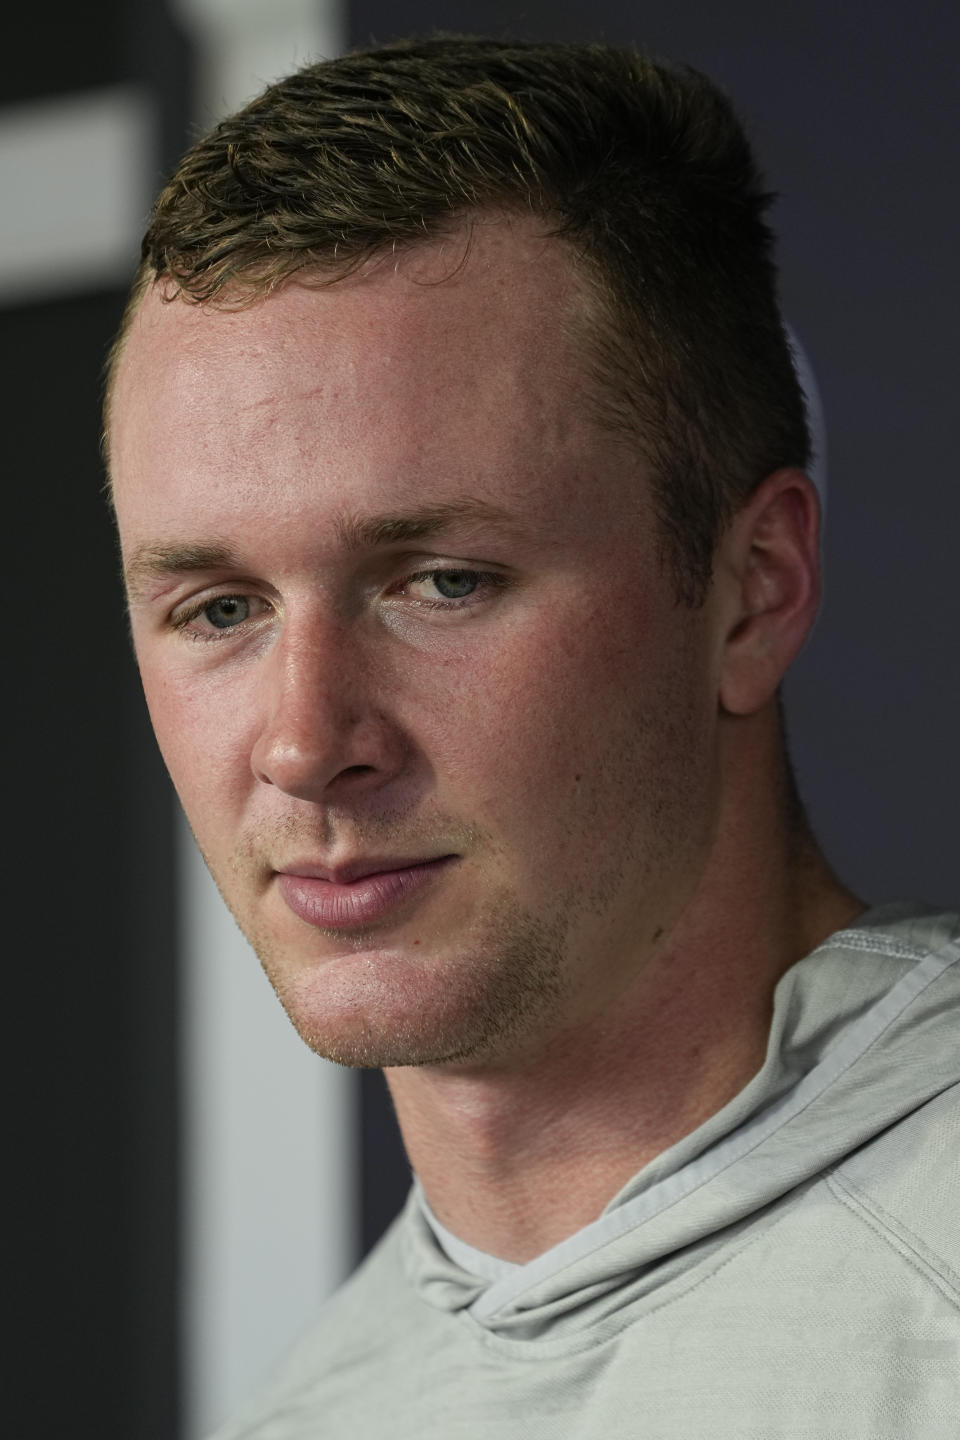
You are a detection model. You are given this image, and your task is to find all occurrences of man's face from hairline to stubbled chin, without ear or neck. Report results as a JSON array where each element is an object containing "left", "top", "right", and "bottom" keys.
[{"left": 111, "top": 220, "right": 717, "bottom": 1066}]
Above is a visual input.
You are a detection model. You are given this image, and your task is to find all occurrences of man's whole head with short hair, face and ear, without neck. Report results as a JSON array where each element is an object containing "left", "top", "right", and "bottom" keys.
[{"left": 109, "top": 33, "right": 816, "bottom": 1064}]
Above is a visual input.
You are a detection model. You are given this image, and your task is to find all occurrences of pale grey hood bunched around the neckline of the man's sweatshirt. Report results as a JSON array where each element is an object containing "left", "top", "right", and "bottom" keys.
[{"left": 402, "top": 904, "right": 960, "bottom": 1342}]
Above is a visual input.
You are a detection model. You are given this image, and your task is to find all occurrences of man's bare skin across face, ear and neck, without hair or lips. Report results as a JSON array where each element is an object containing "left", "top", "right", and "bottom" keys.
[{"left": 111, "top": 220, "right": 861, "bottom": 1259}]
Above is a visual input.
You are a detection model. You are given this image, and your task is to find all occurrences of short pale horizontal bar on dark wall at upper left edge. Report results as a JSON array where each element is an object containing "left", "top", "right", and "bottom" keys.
[{"left": 0, "top": 86, "right": 154, "bottom": 305}]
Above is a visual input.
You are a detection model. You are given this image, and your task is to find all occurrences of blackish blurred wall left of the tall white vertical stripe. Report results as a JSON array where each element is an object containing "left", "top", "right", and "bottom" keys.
[{"left": 0, "top": 0, "right": 183, "bottom": 1440}]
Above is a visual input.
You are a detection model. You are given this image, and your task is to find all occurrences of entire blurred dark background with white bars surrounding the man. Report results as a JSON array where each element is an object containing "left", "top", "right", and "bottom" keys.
[{"left": 0, "top": 0, "right": 960, "bottom": 1440}]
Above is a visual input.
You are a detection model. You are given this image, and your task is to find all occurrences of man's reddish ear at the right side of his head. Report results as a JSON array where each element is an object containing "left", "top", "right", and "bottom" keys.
[{"left": 714, "top": 469, "right": 820, "bottom": 716}]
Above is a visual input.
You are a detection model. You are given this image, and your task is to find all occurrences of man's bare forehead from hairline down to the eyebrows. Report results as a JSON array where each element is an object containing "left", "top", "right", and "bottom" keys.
[{"left": 111, "top": 207, "right": 653, "bottom": 583}]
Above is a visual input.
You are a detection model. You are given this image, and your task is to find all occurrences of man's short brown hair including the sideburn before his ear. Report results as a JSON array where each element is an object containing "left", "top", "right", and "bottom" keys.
[{"left": 105, "top": 36, "right": 810, "bottom": 606}]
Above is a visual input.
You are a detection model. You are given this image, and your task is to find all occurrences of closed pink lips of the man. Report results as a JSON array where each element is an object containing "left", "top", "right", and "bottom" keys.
[{"left": 276, "top": 855, "right": 459, "bottom": 930}]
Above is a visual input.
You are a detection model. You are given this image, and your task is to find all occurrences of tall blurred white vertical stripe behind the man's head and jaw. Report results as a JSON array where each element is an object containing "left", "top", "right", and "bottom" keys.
[{"left": 176, "top": 0, "right": 352, "bottom": 1440}]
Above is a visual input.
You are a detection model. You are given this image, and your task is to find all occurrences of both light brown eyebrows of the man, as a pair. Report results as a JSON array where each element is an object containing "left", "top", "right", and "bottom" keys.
[{"left": 124, "top": 497, "right": 520, "bottom": 595}]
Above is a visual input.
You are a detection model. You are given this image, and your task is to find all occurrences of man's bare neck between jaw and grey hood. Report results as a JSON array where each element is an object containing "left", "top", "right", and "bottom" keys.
[{"left": 387, "top": 731, "right": 864, "bottom": 1263}]
